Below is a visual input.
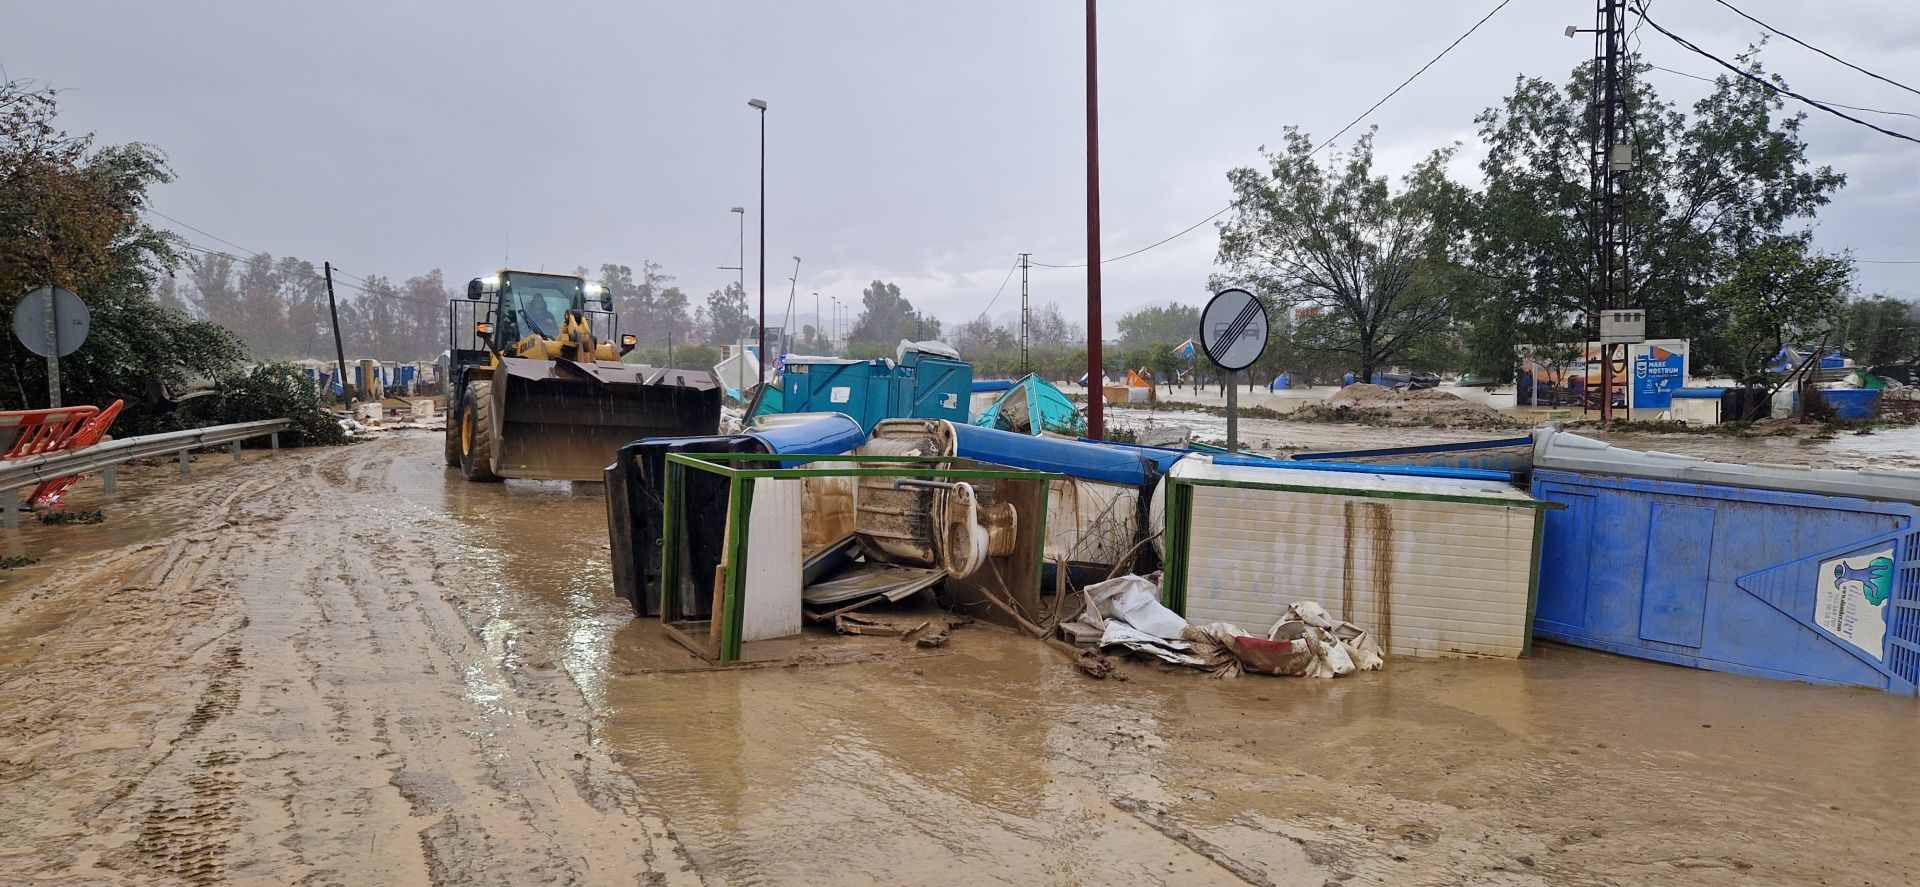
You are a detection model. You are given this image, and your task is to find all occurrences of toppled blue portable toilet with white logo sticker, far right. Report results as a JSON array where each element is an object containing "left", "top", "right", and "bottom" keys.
[{"left": 1532, "top": 430, "right": 1920, "bottom": 695}]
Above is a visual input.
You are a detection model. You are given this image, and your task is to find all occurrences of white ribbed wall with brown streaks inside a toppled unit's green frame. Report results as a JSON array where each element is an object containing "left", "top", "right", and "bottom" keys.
[{"left": 1187, "top": 468, "right": 1538, "bottom": 657}]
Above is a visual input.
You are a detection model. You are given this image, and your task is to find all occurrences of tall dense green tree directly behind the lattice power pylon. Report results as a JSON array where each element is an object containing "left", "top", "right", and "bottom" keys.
[{"left": 1461, "top": 50, "right": 1845, "bottom": 378}]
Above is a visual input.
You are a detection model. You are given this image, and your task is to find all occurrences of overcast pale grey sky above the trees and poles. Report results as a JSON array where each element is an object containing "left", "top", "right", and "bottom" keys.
[{"left": 0, "top": 0, "right": 1920, "bottom": 336}]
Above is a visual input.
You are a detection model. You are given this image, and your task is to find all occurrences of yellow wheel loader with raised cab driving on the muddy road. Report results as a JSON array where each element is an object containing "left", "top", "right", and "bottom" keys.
[{"left": 445, "top": 271, "right": 720, "bottom": 480}]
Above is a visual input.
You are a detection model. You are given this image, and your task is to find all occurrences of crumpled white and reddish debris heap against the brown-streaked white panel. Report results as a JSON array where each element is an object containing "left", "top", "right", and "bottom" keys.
[{"left": 1060, "top": 574, "right": 1386, "bottom": 678}]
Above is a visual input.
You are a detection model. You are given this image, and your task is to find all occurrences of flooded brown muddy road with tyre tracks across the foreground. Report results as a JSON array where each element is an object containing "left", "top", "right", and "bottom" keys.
[{"left": 0, "top": 432, "right": 1920, "bottom": 885}]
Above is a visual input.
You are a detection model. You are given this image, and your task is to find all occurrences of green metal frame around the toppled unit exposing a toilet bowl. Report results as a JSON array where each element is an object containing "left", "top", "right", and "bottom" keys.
[{"left": 660, "top": 453, "right": 1066, "bottom": 664}]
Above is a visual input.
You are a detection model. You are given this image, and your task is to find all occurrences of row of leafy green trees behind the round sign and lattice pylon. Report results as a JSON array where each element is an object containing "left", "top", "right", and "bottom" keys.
[{"left": 1190, "top": 52, "right": 1920, "bottom": 380}]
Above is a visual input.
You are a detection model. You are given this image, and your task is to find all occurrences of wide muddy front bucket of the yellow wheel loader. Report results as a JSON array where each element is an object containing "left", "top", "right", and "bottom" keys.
[{"left": 493, "top": 357, "right": 720, "bottom": 480}]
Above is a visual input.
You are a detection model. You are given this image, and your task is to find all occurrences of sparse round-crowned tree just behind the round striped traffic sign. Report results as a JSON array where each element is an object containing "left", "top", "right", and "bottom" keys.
[{"left": 1215, "top": 127, "right": 1469, "bottom": 378}]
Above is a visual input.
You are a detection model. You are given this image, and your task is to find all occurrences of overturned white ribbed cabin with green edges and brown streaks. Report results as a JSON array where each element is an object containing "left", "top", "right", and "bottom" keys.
[{"left": 1156, "top": 457, "right": 1542, "bottom": 657}]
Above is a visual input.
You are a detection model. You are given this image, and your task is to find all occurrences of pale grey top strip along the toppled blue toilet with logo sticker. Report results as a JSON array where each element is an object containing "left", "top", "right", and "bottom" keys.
[{"left": 1534, "top": 428, "right": 1920, "bottom": 503}]
